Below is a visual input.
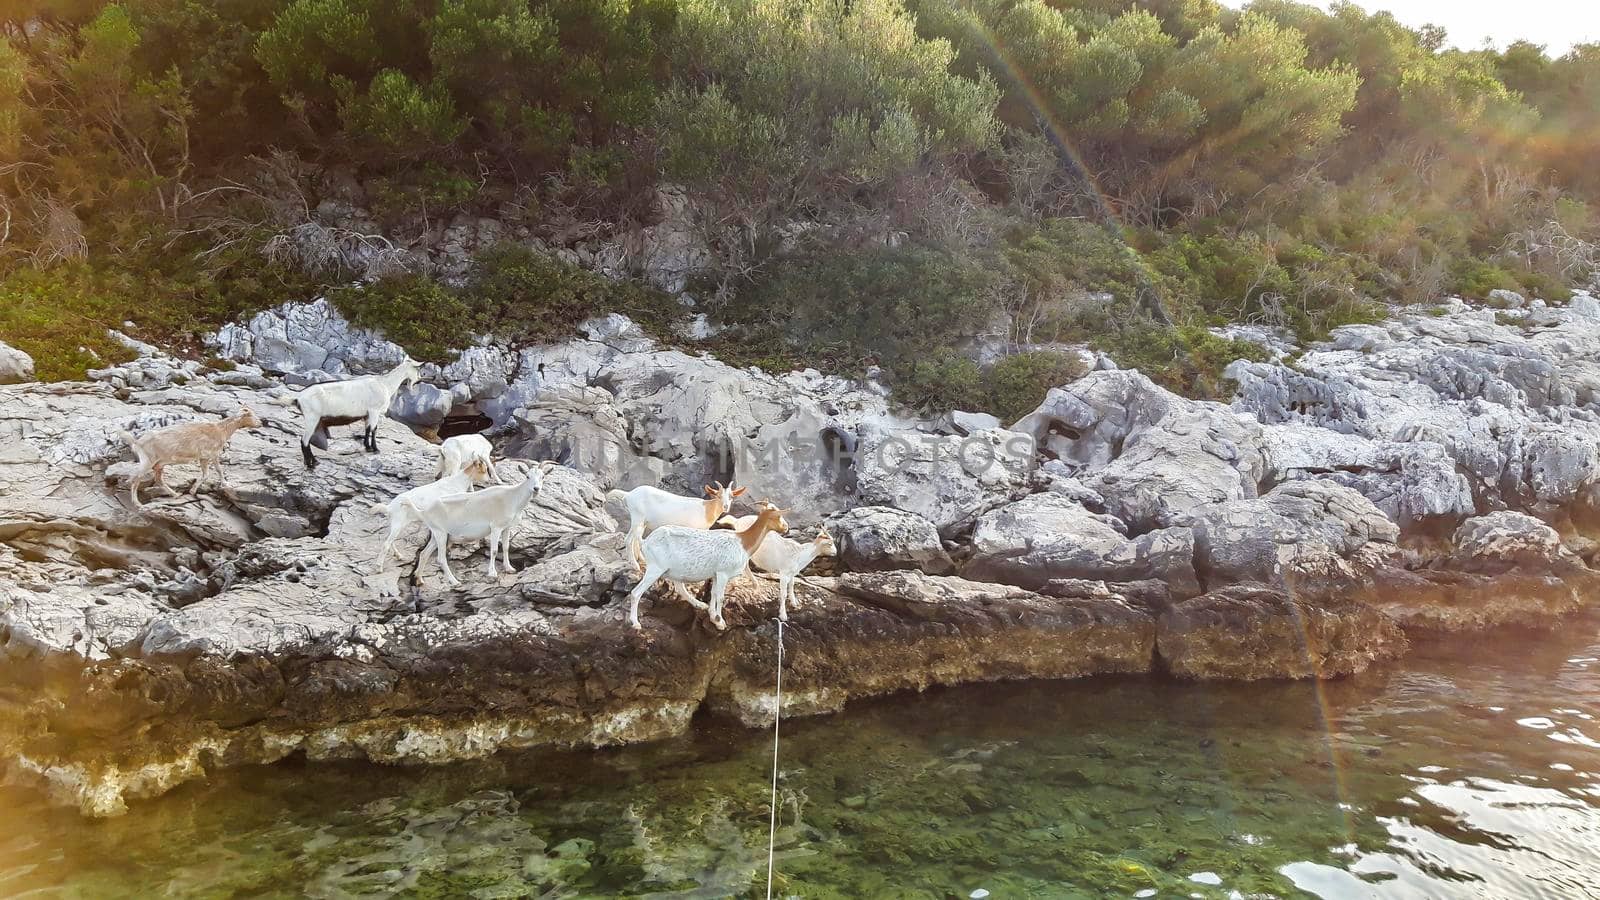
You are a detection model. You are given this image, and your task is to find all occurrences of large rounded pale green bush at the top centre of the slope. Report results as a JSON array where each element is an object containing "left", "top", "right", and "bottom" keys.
[{"left": 656, "top": 0, "right": 997, "bottom": 223}]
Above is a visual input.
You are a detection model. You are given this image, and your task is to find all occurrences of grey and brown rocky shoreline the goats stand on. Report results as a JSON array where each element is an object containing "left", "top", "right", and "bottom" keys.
[{"left": 0, "top": 295, "right": 1600, "bottom": 815}]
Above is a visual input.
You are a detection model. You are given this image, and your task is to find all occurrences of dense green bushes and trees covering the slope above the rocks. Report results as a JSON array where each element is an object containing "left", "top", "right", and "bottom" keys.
[{"left": 0, "top": 0, "right": 1600, "bottom": 405}]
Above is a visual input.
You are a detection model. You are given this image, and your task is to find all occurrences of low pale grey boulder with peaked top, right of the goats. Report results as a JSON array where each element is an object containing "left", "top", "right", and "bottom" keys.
[{"left": 965, "top": 493, "right": 1200, "bottom": 597}]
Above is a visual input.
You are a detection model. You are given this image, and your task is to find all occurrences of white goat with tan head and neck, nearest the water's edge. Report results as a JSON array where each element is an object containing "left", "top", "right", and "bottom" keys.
[{"left": 627, "top": 503, "right": 789, "bottom": 629}]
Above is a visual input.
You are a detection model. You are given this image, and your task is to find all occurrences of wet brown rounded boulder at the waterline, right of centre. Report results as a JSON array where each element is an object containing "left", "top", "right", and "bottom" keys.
[{"left": 1155, "top": 585, "right": 1406, "bottom": 681}]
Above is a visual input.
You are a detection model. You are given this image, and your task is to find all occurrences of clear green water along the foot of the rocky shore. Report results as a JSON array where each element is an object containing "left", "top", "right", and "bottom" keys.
[{"left": 0, "top": 621, "right": 1600, "bottom": 898}]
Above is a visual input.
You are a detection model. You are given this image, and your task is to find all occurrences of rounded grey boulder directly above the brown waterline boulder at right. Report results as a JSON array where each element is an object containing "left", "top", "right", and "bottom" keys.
[{"left": 1194, "top": 480, "right": 1400, "bottom": 594}]
